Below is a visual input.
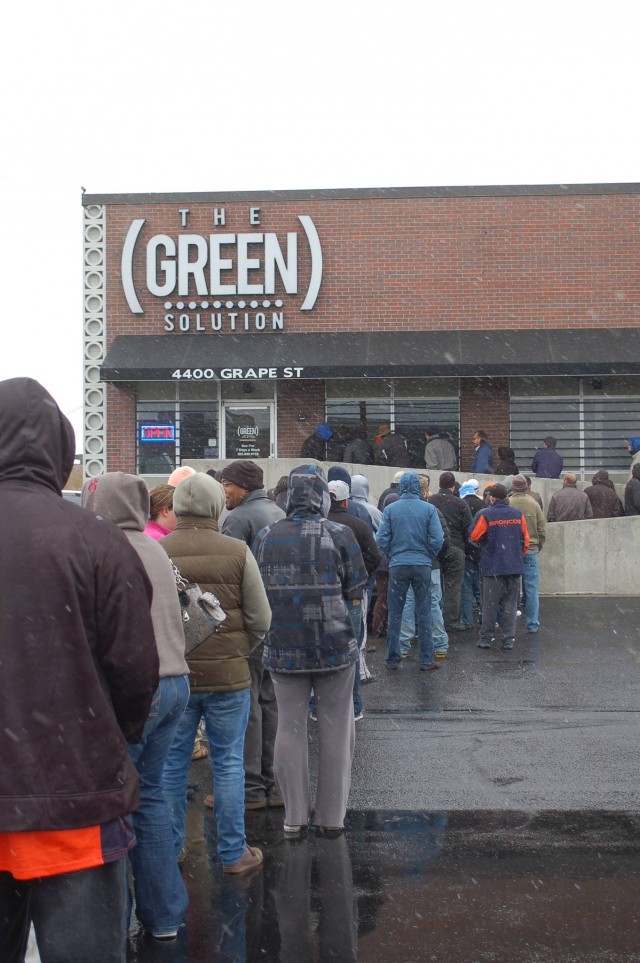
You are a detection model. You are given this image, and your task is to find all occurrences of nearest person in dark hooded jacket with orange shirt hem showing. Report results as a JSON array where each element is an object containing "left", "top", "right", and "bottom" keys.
[{"left": 0, "top": 378, "right": 159, "bottom": 961}]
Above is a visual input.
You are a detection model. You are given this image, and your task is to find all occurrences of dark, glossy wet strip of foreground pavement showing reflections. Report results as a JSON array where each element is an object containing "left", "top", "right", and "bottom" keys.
[{"left": 130, "top": 802, "right": 640, "bottom": 963}]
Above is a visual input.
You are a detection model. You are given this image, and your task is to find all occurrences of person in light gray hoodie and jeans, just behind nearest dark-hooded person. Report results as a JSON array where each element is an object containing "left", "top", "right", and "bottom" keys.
[{"left": 82, "top": 472, "right": 189, "bottom": 942}]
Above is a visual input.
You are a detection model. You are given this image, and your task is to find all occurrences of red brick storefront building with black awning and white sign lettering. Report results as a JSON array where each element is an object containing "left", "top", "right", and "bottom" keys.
[{"left": 82, "top": 184, "right": 640, "bottom": 475}]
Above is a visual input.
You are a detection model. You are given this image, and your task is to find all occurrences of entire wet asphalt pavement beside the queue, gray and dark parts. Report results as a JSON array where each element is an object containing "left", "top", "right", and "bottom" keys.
[{"left": 130, "top": 598, "right": 640, "bottom": 963}]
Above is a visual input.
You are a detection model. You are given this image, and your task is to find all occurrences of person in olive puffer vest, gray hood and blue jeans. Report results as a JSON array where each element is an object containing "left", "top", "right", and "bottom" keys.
[{"left": 159, "top": 472, "right": 271, "bottom": 874}]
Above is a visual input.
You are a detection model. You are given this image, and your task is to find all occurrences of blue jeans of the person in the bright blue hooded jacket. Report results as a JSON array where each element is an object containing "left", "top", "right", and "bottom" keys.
[{"left": 386, "top": 565, "right": 433, "bottom": 666}]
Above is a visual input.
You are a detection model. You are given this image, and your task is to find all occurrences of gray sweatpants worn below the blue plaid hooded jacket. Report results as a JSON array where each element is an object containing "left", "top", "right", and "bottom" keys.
[{"left": 271, "top": 665, "right": 355, "bottom": 827}]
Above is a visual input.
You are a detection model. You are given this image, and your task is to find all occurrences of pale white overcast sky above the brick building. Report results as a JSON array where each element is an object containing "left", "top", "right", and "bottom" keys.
[{"left": 0, "top": 0, "right": 640, "bottom": 449}]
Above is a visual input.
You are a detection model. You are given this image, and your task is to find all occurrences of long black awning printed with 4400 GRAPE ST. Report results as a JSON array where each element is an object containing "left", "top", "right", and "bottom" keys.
[{"left": 101, "top": 328, "right": 640, "bottom": 382}]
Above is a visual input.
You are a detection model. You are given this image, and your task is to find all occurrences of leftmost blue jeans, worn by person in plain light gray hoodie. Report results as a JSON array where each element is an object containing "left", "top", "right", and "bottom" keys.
[{"left": 127, "top": 675, "right": 189, "bottom": 936}]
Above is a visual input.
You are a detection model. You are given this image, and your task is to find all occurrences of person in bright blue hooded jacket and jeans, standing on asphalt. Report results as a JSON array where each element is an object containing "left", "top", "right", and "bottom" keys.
[{"left": 376, "top": 471, "right": 444, "bottom": 671}]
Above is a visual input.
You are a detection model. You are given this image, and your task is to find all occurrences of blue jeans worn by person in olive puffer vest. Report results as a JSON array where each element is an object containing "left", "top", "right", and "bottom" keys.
[{"left": 163, "top": 688, "right": 251, "bottom": 866}]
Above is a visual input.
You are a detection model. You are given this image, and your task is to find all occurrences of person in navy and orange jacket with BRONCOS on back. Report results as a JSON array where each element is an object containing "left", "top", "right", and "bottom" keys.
[{"left": 469, "top": 485, "right": 529, "bottom": 649}]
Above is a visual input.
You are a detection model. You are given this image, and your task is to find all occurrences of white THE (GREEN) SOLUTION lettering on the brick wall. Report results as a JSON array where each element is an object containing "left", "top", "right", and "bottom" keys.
[{"left": 121, "top": 207, "right": 322, "bottom": 333}]
